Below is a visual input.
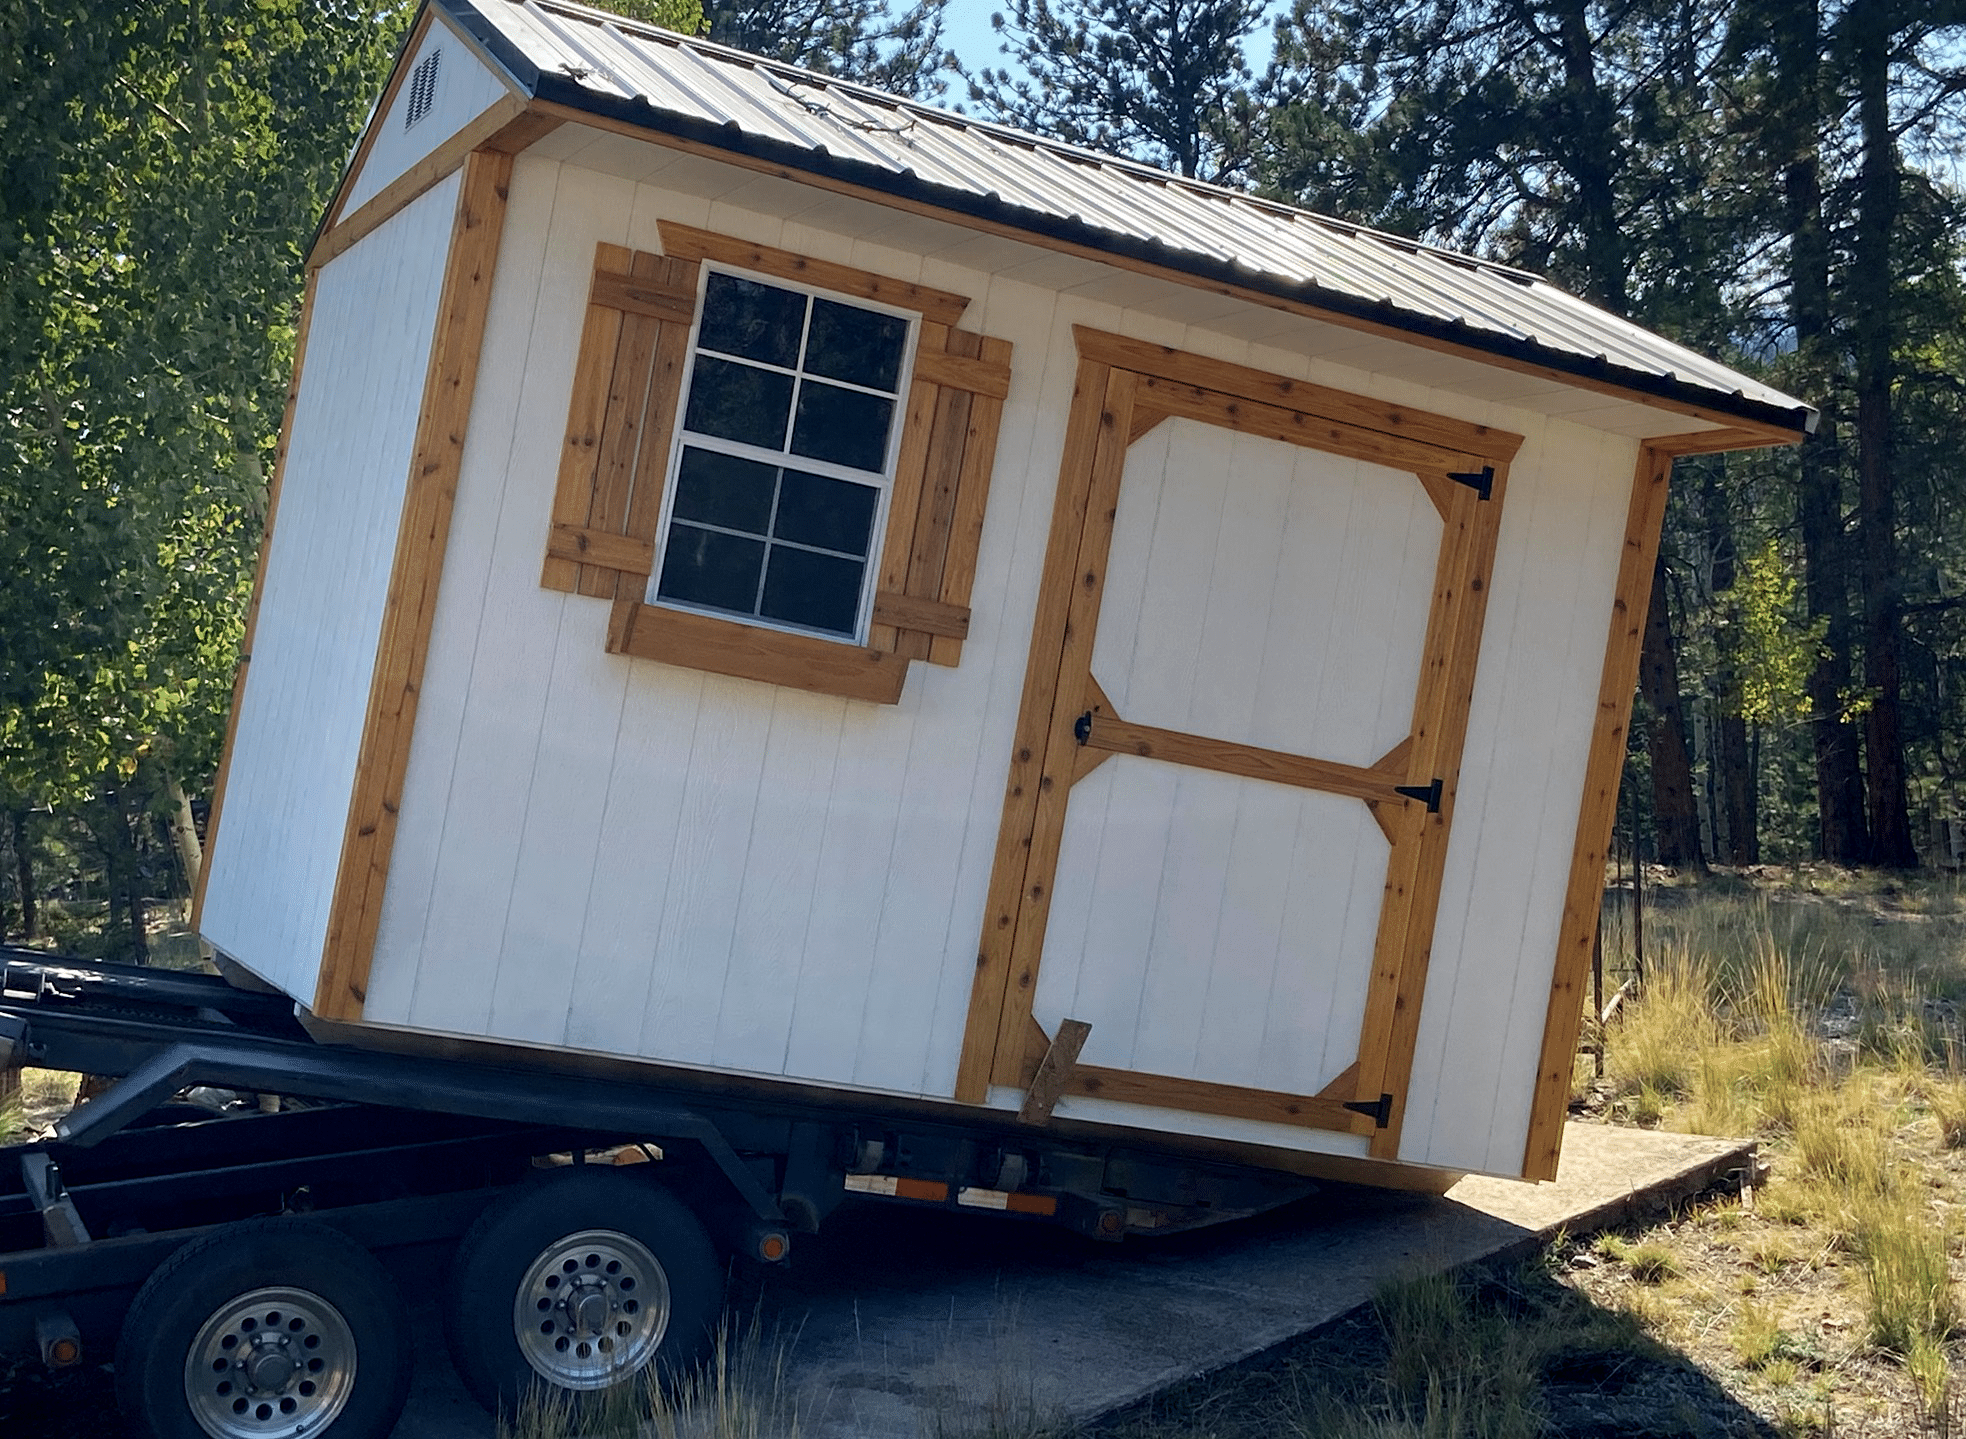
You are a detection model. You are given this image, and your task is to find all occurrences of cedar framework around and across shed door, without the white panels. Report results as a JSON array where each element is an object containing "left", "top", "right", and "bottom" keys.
[{"left": 955, "top": 326, "right": 1522, "bottom": 1158}]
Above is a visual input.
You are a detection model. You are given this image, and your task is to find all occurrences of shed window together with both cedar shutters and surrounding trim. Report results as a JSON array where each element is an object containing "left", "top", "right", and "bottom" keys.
[{"left": 539, "top": 220, "right": 1011, "bottom": 704}]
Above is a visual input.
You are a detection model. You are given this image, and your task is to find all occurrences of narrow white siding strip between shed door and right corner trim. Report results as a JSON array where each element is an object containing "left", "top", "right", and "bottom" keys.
[{"left": 1400, "top": 421, "right": 1638, "bottom": 1174}]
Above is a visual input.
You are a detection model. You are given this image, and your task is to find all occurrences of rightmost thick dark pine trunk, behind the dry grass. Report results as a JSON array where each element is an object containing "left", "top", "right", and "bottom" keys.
[{"left": 1850, "top": 0, "right": 1919, "bottom": 869}]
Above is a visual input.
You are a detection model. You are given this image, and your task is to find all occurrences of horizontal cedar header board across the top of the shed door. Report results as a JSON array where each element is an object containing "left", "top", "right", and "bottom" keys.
[{"left": 1071, "top": 324, "right": 1524, "bottom": 462}]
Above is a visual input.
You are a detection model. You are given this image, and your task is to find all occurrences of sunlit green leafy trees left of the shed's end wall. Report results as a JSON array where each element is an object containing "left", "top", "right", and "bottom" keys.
[{"left": 0, "top": 0, "right": 407, "bottom": 939}]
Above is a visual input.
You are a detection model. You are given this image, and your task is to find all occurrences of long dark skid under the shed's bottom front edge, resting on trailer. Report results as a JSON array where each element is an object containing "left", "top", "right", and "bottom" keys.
[{"left": 295, "top": 1005, "right": 1463, "bottom": 1193}]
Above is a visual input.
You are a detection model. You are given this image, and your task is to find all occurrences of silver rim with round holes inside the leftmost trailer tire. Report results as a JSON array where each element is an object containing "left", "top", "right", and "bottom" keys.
[{"left": 185, "top": 1286, "right": 356, "bottom": 1439}]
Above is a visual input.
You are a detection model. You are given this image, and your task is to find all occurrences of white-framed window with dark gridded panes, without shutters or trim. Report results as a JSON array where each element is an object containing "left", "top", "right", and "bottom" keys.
[{"left": 655, "top": 267, "right": 912, "bottom": 639}]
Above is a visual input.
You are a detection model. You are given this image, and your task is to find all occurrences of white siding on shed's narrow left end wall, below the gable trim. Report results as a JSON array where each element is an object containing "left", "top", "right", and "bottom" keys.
[{"left": 202, "top": 179, "right": 458, "bottom": 999}]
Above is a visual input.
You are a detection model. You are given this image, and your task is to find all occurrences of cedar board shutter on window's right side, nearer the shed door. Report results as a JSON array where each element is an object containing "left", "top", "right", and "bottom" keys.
[{"left": 867, "top": 320, "right": 1011, "bottom": 664}]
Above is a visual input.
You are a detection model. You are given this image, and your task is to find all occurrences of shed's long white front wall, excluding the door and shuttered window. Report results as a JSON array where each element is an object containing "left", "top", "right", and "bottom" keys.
[{"left": 346, "top": 151, "right": 1636, "bottom": 1174}]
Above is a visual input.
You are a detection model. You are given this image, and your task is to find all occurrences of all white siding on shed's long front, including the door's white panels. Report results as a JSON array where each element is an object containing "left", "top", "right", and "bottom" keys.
[{"left": 336, "top": 146, "right": 1632, "bottom": 1172}]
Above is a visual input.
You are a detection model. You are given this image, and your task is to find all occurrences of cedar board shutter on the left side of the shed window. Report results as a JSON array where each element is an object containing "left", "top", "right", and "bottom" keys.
[{"left": 539, "top": 244, "right": 698, "bottom": 600}]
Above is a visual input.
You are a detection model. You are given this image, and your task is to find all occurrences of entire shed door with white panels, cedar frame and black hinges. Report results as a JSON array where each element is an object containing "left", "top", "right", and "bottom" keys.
[{"left": 965, "top": 332, "right": 1514, "bottom": 1154}]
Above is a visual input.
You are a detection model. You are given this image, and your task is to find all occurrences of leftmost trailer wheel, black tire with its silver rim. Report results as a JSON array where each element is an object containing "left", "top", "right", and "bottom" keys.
[{"left": 116, "top": 1219, "right": 411, "bottom": 1439}]
